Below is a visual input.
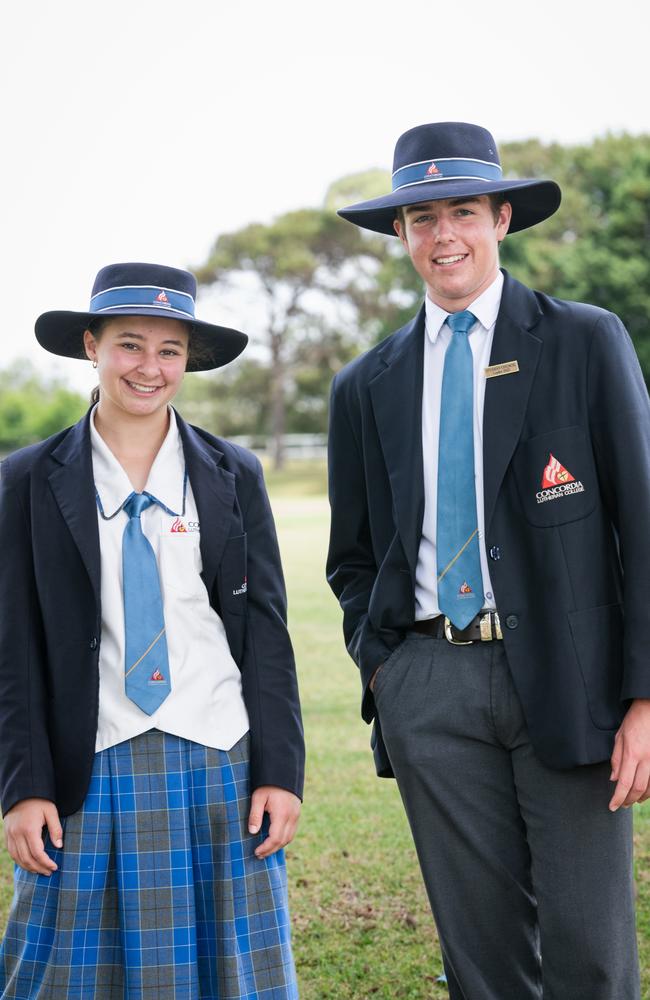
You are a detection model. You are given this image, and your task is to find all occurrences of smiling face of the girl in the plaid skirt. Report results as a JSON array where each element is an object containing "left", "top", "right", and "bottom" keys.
[{"left": 84, "top": 316, "right": 189, "bottom": 422}]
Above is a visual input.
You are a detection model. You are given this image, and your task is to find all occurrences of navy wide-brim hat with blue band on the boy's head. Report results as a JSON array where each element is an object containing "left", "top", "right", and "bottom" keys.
[{"left": 338, "top": 122, "right": 562, "bottom": 236}]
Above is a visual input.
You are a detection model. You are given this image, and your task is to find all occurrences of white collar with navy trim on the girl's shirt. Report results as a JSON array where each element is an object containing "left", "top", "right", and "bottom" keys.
[{"left": 90, "top": 406, "right": 185, "bottom": 517}]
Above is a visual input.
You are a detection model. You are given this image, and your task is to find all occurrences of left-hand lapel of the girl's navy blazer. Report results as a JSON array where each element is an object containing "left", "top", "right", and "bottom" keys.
[{"left": 49, "top": 411, "right": 101, "bottom": 607}]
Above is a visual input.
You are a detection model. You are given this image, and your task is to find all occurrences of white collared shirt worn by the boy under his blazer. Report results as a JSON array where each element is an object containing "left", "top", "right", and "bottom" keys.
[{"left": 415, "top": 271, "right": 503, "bottom": 621}]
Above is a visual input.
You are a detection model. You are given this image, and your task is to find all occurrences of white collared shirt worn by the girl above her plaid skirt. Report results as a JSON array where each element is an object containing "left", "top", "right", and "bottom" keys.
[{"left": 90, "top": 407, "right": 248, "bottom": 750}]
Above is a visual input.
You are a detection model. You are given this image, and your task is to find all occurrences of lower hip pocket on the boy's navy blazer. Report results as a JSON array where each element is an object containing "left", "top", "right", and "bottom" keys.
[{"left": 568, "top": 604, "right": 624, "bottom": 729}]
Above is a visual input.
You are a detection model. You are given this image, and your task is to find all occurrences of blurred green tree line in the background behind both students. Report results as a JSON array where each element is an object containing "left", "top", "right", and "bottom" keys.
[{"left": 0, "top": 134, "right": 650, "bottom": 464}]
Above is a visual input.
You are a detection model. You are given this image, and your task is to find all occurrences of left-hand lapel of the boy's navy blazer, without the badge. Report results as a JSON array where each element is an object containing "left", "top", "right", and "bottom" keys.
[{"left": 369, "top": 306, "right": 425, "bottom": 574}]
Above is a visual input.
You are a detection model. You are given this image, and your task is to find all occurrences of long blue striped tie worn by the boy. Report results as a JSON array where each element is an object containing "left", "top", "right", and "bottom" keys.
[{"left": 436, "top": 309, "right": 483, "bottom": 628}]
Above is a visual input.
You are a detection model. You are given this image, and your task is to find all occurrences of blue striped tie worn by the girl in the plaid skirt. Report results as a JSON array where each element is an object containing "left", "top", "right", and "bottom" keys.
[{"left": 122, "top": 493, "right": 171, "bottom": 715}]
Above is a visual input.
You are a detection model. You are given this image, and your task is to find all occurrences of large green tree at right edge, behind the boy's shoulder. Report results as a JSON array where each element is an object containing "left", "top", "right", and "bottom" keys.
[{"left": 502, "top": 134, "right": 650, "bottom": 381}]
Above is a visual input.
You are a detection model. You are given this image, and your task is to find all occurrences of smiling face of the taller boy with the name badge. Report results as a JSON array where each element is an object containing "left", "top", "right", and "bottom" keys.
[{"left": 394, "top": 195, "right": 512, "bottom": 312}]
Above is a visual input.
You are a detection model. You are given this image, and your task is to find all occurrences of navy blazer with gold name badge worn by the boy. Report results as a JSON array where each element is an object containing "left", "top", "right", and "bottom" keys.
[{"left": 327, "top": 274, "right": 650, "bottom": 776}]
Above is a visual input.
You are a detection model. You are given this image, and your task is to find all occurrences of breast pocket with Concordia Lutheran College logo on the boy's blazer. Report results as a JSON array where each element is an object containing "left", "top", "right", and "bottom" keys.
[{"left": 513, "top": 426, "right": 598, "bottom": 528}]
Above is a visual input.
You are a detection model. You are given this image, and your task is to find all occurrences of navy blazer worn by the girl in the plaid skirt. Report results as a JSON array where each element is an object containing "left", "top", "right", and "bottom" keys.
[{"left": 0, "top": 414, "right": 304, "bottom": 816}]
